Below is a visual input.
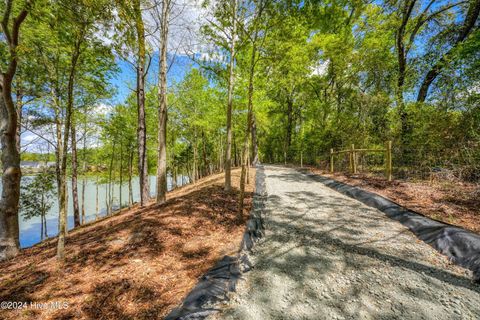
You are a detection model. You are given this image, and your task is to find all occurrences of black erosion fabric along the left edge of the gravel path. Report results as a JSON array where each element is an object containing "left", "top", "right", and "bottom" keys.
[{"left": 165, "top": 165, "right": 266, "bottom": 320}]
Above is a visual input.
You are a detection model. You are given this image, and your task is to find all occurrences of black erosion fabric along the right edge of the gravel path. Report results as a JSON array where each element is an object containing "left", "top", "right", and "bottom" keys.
[{"left": 305, "top": 173, "right": 480, "bottom": 283}]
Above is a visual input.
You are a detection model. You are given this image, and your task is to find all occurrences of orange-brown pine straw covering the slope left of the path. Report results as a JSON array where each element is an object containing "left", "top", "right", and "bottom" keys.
[{"left": 0, "top": 169, "right": 255, "bottom": 320}]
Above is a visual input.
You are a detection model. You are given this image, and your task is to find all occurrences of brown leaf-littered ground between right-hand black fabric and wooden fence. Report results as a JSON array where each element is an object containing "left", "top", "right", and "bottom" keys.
[{"left": 309, "top": 167, "right": 480, "bottom": 233}]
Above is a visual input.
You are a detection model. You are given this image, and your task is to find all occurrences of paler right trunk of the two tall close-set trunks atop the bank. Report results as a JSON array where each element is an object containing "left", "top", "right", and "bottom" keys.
[{"left": 157, "top": 0, "right": 170, "bottom": 203}]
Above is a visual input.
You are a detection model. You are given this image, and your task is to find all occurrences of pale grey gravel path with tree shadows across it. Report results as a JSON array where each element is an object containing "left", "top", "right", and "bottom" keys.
[{"left": 216, "top": 166, "right": 480, "bottom": 320}]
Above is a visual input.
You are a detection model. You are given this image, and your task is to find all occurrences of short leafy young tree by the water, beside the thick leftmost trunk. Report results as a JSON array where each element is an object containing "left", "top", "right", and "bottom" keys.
[{"left": 20, "top": 171, "right": 55, "bottom": 240}]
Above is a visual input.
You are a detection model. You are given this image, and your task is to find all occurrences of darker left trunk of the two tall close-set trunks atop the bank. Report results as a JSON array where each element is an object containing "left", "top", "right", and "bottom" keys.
[{"left": 134, "top": 0, "right": 150, "bottom": 207}]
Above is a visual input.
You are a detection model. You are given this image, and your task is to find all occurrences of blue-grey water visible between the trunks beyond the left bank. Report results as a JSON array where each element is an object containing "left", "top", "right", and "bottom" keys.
[{"left": 0, "top": 176, "right": 188, "bottom": 248}]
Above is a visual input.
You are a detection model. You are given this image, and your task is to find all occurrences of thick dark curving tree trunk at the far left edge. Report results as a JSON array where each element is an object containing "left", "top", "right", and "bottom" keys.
[{"left": 0, "top": 1, "right": 28, "bottom": 260}]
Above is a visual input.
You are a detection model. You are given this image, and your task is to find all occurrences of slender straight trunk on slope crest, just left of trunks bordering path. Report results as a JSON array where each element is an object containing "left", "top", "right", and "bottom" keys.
[{"left": 225, "top": 0, "right": 237, "bottom": 192}]
